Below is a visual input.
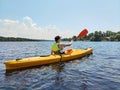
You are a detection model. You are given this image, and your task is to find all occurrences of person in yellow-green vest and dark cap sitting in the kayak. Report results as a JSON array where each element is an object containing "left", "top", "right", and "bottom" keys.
[{"left": 51, "top": 36, "right": 73, "bottom": 55}]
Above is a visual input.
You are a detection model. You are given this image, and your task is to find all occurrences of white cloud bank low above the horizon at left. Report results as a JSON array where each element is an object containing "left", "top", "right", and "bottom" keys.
[{"left": 0, "top": 16, "right": 74, "bottom": 39}]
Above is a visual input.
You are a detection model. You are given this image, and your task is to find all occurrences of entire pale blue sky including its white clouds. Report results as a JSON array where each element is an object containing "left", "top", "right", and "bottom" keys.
[{"left": 0, "top": 0, "right": 120, "bottom": 39}]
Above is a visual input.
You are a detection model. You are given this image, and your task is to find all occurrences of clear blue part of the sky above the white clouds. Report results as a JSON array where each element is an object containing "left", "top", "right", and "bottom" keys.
[{"left": 0, "top": 0, "right": 120, "bottom": 39}]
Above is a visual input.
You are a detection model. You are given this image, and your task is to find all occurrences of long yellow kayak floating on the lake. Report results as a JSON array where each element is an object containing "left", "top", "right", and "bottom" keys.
[{"left": 4, "top": 48, "right": 93, "bottom": 70}]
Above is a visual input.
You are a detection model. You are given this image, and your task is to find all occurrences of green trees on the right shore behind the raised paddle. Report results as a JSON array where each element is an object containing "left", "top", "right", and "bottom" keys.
[{"left": 62, "top": 31, "right": 120, "bottom": 41}]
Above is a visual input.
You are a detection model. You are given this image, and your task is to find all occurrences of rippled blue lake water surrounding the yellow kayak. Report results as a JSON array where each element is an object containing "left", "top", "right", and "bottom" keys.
[{"left": 0, "top": 42, "right": 120, "bottom": 90}]
